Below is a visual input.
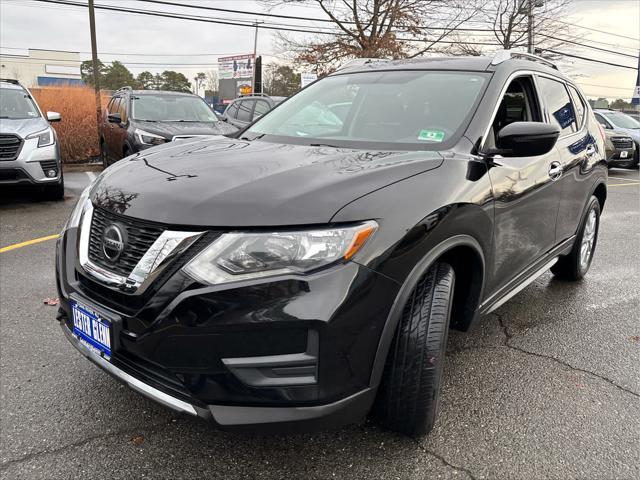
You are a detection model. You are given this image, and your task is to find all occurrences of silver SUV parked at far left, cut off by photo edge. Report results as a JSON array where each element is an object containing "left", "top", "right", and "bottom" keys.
[{"left": 0, "top": 79, "right": 64, "bottom": 200}]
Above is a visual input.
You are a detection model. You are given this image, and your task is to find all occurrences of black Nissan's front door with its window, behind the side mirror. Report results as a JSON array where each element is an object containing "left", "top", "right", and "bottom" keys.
[{"left": 484, "top": 75, "right": 561, "bottom": 291}]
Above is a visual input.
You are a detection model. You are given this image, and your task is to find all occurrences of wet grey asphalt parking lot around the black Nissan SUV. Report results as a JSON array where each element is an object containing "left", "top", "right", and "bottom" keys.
[{"left": 0, "top": 169, "right": 640, "bottom": 479}]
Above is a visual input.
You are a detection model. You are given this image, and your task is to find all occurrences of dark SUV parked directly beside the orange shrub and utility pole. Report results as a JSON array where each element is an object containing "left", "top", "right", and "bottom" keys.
[{"left": 100, "top": 87, "right": 238, "bottom": 167}]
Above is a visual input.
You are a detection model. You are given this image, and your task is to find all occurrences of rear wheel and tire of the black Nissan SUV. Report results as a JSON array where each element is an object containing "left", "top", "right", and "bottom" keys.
[{"left": 551, "top": 196, "right": 600, "bottom": 281}]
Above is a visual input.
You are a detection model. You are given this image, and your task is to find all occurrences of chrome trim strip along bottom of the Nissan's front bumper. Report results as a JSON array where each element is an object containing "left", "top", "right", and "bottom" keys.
[{"left": 60, "top": 323, "right": 198, "bottom": 416}]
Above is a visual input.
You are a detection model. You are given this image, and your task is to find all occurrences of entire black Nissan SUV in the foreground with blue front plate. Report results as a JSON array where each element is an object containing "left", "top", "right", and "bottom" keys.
[{"left": 57, "top": 52, "right": 607, "bottom": 435}]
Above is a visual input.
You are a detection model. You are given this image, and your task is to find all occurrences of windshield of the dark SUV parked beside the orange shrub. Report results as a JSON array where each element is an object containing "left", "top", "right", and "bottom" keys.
[{"left": 131, "top": 94, "right": 218, "bottom": 122}]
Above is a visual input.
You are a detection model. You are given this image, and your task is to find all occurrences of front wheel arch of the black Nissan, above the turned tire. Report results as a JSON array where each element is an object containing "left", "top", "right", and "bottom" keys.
[{"left": 370, "top": 234, "right": 485, "bottom": 387}]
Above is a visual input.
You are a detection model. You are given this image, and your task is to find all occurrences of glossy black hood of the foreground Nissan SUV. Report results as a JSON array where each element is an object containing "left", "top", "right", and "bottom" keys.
[{"left": 91, "top": 137, "right": 443, "bottom": 227}]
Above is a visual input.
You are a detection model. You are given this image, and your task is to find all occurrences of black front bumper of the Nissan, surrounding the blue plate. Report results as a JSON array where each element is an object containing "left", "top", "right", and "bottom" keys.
[{"left": 56, "top": 225, "right": 398, "bottom": 431}]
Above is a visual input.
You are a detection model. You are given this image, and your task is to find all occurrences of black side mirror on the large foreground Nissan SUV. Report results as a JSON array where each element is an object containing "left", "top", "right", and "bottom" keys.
[{"left": 487, "top": 122, "right": 560, "bottom": 157}]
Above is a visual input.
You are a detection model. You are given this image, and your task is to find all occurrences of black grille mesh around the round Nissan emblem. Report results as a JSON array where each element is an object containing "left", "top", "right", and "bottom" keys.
[{"left": 89, "top": 208, "right": 164, "bottom": 277}]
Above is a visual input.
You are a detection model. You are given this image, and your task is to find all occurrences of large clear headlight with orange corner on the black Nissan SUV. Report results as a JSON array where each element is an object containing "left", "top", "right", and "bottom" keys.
[{"left": 184, "top": 221, "right": 378, "bottom": 285}]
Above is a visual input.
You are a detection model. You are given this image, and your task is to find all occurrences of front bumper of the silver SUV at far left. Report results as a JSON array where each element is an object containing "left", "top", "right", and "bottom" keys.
[{"left": 0, "top": 138, "right": 62, "bottom": 185}]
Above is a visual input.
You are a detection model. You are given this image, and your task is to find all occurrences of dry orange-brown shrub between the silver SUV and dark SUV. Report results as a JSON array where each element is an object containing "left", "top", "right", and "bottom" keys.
[{"left": 31, "top": 86, "right": 109, "bottom": 163}]
